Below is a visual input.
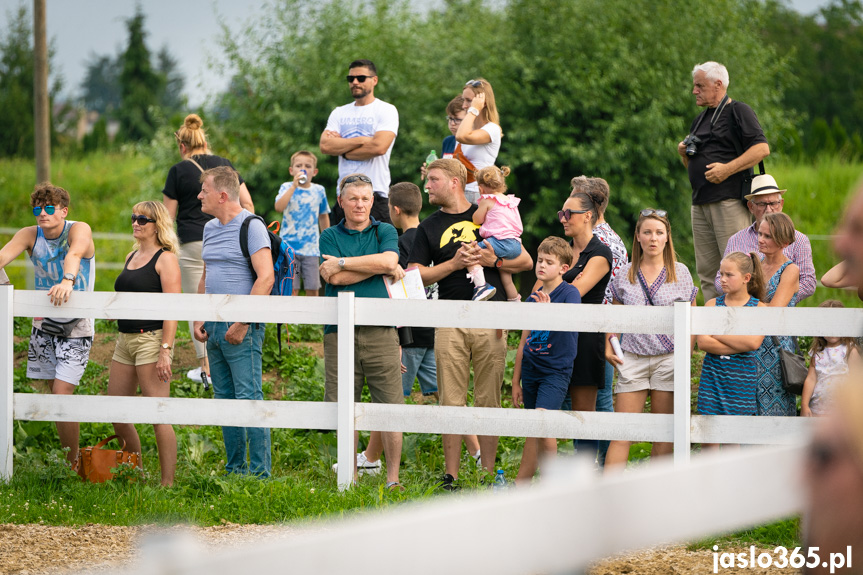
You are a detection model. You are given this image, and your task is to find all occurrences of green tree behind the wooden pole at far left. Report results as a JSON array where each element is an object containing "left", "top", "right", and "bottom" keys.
[{"left": 0, "top": 4, "right": 60, "bottom": 157}]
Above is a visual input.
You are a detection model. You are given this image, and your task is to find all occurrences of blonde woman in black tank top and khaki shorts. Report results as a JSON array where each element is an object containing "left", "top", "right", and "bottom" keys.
[{"left": 108, "top": 202, "right": 181, "bottom": 486}]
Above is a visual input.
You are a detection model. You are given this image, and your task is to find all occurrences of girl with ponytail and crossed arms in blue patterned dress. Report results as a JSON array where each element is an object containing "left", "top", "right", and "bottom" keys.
[{"left": 697, "top": 252, "right": 764, "bottom": 440}]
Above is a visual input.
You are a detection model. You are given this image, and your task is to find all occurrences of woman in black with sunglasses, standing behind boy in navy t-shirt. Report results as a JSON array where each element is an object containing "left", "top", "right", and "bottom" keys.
[{"left": 557, "top": 186, "right": 614, "bottom": 446}]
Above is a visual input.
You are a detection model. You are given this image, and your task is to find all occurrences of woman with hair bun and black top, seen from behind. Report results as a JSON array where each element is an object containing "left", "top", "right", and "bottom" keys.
[{"left": 162, "top": 114, "right": 255, "bottom": 381}]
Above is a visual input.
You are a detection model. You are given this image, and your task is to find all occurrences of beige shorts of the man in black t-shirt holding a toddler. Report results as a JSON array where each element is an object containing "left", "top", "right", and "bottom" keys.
[{"left": 435, "top": 327, "right": 506, "bottom": 407}]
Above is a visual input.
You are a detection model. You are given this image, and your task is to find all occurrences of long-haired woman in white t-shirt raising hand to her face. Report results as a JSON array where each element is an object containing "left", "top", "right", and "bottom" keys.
[{"left": 453, "top": 78, "right": 503, "bottom": 205}]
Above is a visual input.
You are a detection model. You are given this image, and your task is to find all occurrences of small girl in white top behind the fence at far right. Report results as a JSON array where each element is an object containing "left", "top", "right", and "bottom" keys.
[{"left": 800, "top": 299, "right": 860, "bottom": 417}]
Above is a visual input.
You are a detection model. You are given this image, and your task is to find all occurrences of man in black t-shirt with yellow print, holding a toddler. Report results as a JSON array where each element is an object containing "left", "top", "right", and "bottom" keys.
[{"left": 408, "top": 160, "right": 533, "bottom": 490}]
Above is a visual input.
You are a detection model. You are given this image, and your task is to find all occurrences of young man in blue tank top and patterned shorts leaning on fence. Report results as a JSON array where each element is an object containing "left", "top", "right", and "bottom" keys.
[{"left": 0, "top": 183, "right": 96, "bottom": 465}]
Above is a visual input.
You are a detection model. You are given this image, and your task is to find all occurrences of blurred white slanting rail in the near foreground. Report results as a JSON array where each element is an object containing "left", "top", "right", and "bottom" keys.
[{"left": 113, "top": 447, "right": 804, "bottom": 575}]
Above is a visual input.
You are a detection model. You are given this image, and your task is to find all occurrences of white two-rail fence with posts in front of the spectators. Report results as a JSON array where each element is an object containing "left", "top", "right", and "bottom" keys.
[{"left": 0, "top": 286, "right": 863, "bottom": 488}]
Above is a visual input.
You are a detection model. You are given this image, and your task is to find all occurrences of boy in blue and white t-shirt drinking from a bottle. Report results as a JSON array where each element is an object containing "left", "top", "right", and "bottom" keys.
[{"left": 275, "top": 150, "right": 330, "bottom": 296}]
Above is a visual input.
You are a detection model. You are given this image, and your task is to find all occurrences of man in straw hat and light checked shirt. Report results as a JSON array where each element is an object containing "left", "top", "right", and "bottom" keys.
[{"left": 714, "top": 174, "right": 815, "bottom": 300}]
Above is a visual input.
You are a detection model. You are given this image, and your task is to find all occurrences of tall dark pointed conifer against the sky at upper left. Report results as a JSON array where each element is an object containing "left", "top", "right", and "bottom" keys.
[{"left": 118, "top": 6, "right": 165, "bottom": 141}]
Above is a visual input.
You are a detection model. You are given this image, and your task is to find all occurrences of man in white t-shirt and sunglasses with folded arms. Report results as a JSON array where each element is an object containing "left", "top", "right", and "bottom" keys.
[{"left": 321, "top": 60, "right": 399, "bottom": 224}]
